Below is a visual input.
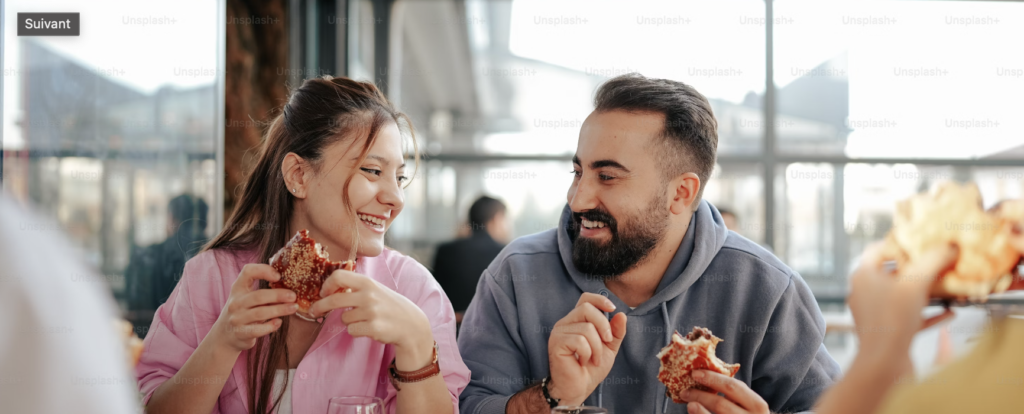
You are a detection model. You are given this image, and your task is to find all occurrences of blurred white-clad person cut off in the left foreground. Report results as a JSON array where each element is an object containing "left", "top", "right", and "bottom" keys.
[{"left": 0, "top": 194, "right": 139, "bottom": 414}]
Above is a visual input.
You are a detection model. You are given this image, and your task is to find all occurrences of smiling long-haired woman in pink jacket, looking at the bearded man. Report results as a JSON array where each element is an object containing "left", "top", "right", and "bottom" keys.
[{"left": 136, "top": 77, "right": 469, "bottom": 414}]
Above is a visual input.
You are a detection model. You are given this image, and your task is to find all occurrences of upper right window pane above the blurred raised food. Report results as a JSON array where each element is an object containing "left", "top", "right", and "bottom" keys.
[{"left": 774, "top": 0, "right": 1024, "bottom": 159}]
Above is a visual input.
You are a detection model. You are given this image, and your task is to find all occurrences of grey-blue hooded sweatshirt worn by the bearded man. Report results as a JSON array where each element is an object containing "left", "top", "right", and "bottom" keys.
[{"left": 459, "top": 201, "right": 840, "bottom": 414}]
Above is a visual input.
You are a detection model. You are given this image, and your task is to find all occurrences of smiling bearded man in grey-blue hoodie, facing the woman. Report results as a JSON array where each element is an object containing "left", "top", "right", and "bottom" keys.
[{"left": 459, "top": 74, "right": 840, "bottom": 414}]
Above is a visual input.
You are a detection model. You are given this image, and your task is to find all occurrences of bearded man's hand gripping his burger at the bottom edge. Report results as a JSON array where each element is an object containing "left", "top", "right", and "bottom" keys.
[{"left": 682, "top": 370, "right": 769, "bottom": 414}]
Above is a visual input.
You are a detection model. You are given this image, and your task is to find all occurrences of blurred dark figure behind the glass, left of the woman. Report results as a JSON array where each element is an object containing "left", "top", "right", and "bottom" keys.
[{"left": 125, "top": 194, "right": 210, "bottom": 315}]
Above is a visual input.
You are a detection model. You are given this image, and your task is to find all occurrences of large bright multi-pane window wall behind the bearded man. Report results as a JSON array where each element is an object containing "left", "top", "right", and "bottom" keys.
[{"left": 380, "top": 0, "right": 1024, "bottom": 308}]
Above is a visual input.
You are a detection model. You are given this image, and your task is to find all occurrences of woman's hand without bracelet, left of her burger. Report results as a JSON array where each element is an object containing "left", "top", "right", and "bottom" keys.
[{"left": 210, "top": 263, "right": 298, "bottom": 353}]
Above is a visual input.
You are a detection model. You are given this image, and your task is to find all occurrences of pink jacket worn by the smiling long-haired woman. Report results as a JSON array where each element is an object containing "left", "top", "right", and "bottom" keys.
[{"left": 135, "top": 249, "right": 469, "bottom": 414}]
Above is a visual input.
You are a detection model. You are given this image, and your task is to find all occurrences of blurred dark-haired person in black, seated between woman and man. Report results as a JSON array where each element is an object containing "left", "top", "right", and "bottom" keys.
[{"left": 433, "top": 196, "right": 510, "bottom": 323}]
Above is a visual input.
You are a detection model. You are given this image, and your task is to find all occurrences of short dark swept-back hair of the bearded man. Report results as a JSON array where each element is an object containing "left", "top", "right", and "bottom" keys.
[{"left": 594, "top": 73, "right": 718, "bottom": 202}]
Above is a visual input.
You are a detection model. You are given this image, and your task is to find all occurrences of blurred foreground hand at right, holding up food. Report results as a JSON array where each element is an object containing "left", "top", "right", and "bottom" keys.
[{"left": 847, "top": 243, "right": 958, "bottom": 364}]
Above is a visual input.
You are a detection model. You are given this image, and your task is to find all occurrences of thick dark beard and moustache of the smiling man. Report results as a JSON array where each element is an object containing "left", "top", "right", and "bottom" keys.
[{"left": 565, "top": 197, "right": 669, "bottom": 280}]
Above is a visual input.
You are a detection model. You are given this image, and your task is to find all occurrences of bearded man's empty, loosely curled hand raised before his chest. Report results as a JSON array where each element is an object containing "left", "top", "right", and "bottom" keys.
[{"left": 548, "top": 293, "right": 626, "bottom": 406}]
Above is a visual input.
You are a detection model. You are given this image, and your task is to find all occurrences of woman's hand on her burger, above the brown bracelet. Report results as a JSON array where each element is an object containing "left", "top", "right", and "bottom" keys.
[{"left": 309, "top": 271, "right": 434, "bottom": 371}]
